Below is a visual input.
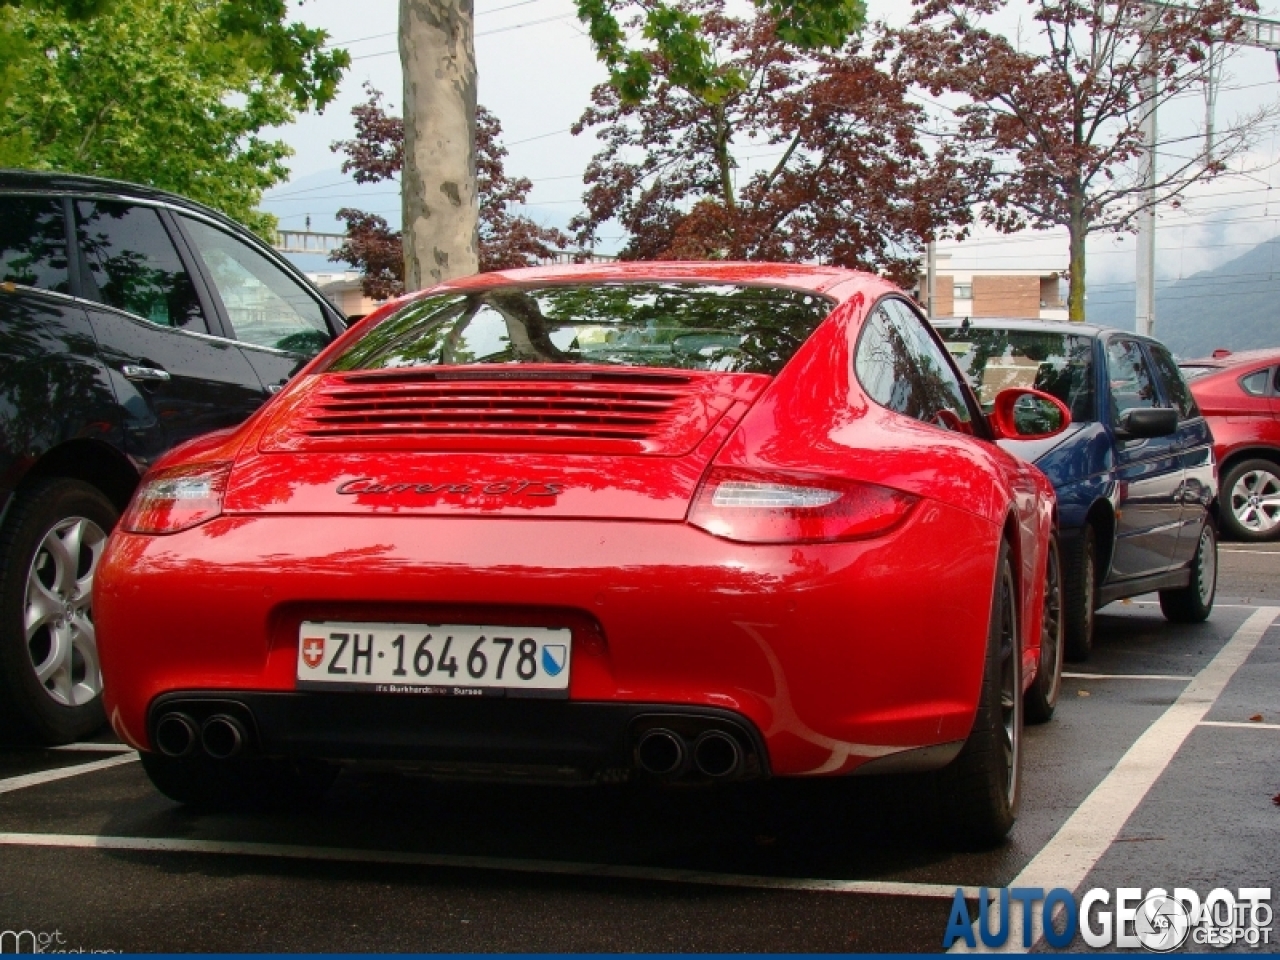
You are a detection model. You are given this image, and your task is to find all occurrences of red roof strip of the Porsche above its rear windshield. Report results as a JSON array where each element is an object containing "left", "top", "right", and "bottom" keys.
[{"left": 430, "top": 260, "right": 890, "bottom": 293}]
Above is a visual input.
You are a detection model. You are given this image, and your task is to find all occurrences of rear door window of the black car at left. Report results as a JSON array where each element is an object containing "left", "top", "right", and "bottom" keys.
[{"left": 76, "top": 200, "right": 207, "bottom": 332}]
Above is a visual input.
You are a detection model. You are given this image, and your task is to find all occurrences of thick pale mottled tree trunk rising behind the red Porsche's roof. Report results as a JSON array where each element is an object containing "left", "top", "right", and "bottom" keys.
[{"left": 399, "top": 0, "right": 480, "bottom": 291}]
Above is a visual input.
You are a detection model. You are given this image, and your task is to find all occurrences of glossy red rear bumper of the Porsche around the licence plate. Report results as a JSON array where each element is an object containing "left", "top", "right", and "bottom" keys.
[{"left": 95, "top": 502, "right": 1000, "bottom": 776}]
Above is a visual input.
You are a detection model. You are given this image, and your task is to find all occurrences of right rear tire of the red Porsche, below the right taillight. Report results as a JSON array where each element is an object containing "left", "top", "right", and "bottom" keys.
[{"left": 938, "top": 541, "right": 1023, "bottom": 850}]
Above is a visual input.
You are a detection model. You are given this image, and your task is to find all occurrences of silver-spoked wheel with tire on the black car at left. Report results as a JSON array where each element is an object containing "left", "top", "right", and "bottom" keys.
[{"left": 0, "top": 477, "right": 119, "bottom": 744}]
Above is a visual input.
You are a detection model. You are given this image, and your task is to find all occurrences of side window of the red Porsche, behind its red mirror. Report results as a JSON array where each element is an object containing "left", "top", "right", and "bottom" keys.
[{"left": 854, "top": 300, "right": 972, "bottom": 429}]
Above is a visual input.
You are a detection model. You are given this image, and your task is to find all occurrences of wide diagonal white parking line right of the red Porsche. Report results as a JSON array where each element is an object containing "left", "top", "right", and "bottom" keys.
[{"left": 950, "top": 607, "right": 1280, "bottom": 954}]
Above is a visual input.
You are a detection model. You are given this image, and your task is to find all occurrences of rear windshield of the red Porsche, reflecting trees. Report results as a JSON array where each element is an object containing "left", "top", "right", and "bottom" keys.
[{"left": 329, "top": 283, "right": 832, "bottom": 374}]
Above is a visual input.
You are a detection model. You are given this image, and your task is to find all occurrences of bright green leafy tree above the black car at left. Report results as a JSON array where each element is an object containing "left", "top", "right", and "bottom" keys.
[{"left": 0, "top": 0, "right": 349, "bottom": 236}]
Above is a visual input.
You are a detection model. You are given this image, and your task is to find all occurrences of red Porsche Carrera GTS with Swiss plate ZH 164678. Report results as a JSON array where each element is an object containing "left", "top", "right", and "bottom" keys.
[{"left": 95, "top": 264, "right": 1070, "bottom": 842}]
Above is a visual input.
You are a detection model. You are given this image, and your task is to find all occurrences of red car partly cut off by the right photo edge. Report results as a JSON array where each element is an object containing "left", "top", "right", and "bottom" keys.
[{"left": 1179, "top": 349, "right": 1280, "bottom": 540}]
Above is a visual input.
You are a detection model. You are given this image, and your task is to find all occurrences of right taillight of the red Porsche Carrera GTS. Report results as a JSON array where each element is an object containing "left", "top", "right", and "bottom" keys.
[{"left": 689, "top": 467, "right": 916, "bottom": 543}]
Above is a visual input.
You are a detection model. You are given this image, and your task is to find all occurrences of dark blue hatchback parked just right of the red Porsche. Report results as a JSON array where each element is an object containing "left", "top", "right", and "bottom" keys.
[{"left": 934, "top": 320, "right": 1217, "bottom": 659}]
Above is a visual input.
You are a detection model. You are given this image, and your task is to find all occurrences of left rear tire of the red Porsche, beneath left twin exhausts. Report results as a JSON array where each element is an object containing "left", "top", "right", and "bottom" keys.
[{"left": 140, "top": 753, "right": 338, "bottom": 810}]
